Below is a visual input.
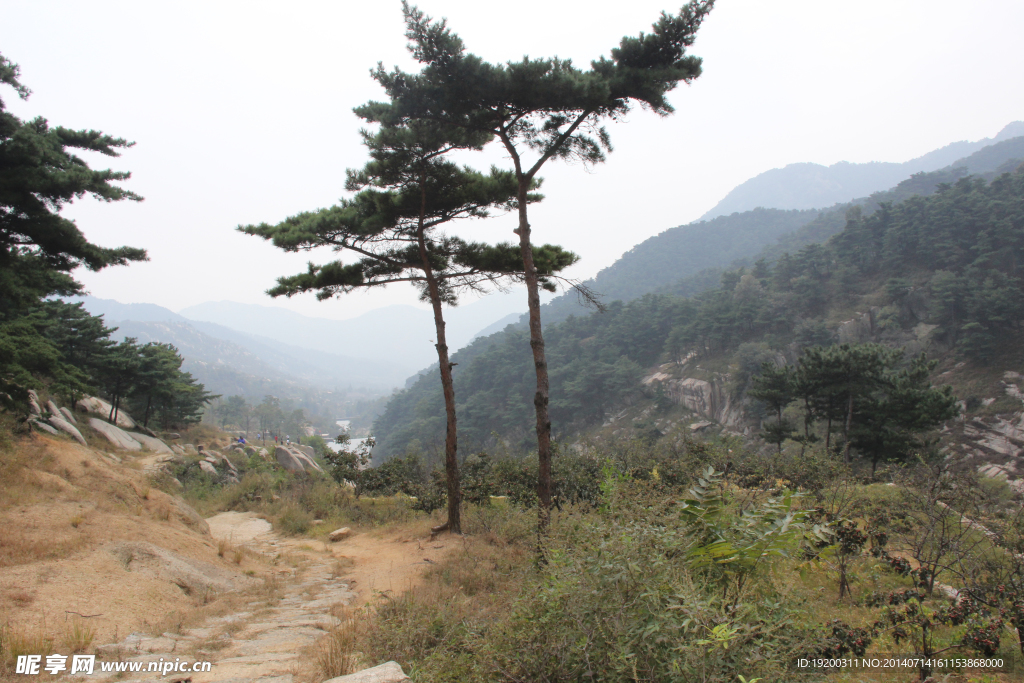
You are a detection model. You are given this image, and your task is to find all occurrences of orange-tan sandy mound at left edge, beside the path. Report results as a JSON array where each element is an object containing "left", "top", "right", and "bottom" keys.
[{"left": 0, "top": 436, "right": 228, "bottom": 642}]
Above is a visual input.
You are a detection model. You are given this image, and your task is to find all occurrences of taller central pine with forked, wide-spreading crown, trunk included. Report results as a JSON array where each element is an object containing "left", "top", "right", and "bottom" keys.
[{"left": 375, "top": 0, "right": 714, "bottom": 531}]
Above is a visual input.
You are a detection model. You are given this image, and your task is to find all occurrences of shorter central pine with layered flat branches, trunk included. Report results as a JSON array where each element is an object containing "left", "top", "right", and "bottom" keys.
[{"left": 240, "top": 108, "right": 577, "bottom": 533}]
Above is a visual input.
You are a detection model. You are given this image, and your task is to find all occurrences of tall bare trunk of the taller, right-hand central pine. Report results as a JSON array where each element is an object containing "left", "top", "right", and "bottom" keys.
[{"left": 517, "top": 177, "right": 551, "bottom": 535}]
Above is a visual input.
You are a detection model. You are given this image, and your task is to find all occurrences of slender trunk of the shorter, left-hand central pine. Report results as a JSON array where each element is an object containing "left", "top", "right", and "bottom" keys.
[{"left": 417, "top": 182, "right": 462, "bottom": 533}]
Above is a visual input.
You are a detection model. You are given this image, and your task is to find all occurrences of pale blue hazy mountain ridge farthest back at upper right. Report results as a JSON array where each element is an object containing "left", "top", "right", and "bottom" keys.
[{"left": 700, "top": 121, "right": 1024, "bottom": 220}]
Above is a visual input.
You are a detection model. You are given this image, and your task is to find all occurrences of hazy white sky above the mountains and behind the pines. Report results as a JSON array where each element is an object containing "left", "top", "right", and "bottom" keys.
[{"left": 0, "top": 0, "right": 1024, "bottom": 318}]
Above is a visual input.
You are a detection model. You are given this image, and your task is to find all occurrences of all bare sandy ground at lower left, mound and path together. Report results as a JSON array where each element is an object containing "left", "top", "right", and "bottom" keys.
[{"left": 0, "top": 436, "right": 461, "bottom": 683}]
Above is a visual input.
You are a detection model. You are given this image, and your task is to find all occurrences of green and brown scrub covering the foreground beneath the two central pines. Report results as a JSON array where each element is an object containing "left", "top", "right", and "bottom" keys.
[{"left": 148, "top": 428, "right": 1024, "bottom": 682}]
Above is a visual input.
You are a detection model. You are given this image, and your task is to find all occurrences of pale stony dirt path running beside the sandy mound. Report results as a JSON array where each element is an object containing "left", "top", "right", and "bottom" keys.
[{"left": 88, "top": 512, "right": 458, "bottom": 683}]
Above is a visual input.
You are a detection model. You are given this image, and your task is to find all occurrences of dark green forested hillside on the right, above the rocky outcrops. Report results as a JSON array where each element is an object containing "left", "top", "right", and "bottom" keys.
[{"left": 375, "top": 163, "right": 1024, "bottom": 460}]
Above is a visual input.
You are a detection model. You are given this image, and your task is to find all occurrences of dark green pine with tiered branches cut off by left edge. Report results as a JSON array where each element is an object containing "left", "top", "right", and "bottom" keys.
[{"left": 0, "top": 55, "right": 146, "bottom": 409}]
